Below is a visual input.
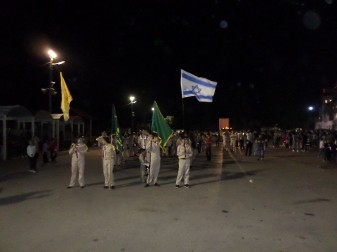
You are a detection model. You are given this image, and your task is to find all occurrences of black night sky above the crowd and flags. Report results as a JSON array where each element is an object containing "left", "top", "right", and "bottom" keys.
[{"left": 0, "top": 0, "right": 337, "bottom": 132}]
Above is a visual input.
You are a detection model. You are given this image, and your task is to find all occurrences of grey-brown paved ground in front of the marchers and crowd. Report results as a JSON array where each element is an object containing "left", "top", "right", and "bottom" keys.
[{"left": 0, "top": 147, "right": 337, "bottom": 252}]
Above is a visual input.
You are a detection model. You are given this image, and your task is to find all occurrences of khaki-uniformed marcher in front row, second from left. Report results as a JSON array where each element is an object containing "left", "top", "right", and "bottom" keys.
[{"left": 98, "top": 137, "right": 116, "bottom": 189}]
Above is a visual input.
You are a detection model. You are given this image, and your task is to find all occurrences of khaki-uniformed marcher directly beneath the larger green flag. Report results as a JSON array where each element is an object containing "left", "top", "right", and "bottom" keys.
[{"left": 145, "top": 133, "right": 160, "bottom": 187}]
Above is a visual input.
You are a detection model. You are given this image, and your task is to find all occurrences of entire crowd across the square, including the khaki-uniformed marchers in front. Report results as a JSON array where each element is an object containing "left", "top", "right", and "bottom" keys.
[{"left": 20, "top": 129, "right": 337, "bottom": 189}]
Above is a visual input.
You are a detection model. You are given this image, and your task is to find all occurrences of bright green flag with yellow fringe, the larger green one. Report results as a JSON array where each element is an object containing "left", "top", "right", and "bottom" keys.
[{"left": 151, "top": 101, "right": 173, "bottom": 148}]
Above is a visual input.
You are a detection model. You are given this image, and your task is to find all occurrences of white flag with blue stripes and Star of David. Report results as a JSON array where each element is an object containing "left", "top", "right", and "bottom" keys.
[{"left": 180, "top": 70, "right": 217, "bottom": 102}]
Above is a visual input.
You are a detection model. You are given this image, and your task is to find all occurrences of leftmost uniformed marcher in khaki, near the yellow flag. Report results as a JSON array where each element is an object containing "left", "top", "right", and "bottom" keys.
[{"left": 67, "top": 137, "right": 88, "bottom": 189}]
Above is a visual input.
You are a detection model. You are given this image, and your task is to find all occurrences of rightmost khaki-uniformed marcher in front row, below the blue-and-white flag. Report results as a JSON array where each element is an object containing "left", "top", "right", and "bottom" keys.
[{"left": 176, "top": 135, "right": 193, "bottom": 188}]
